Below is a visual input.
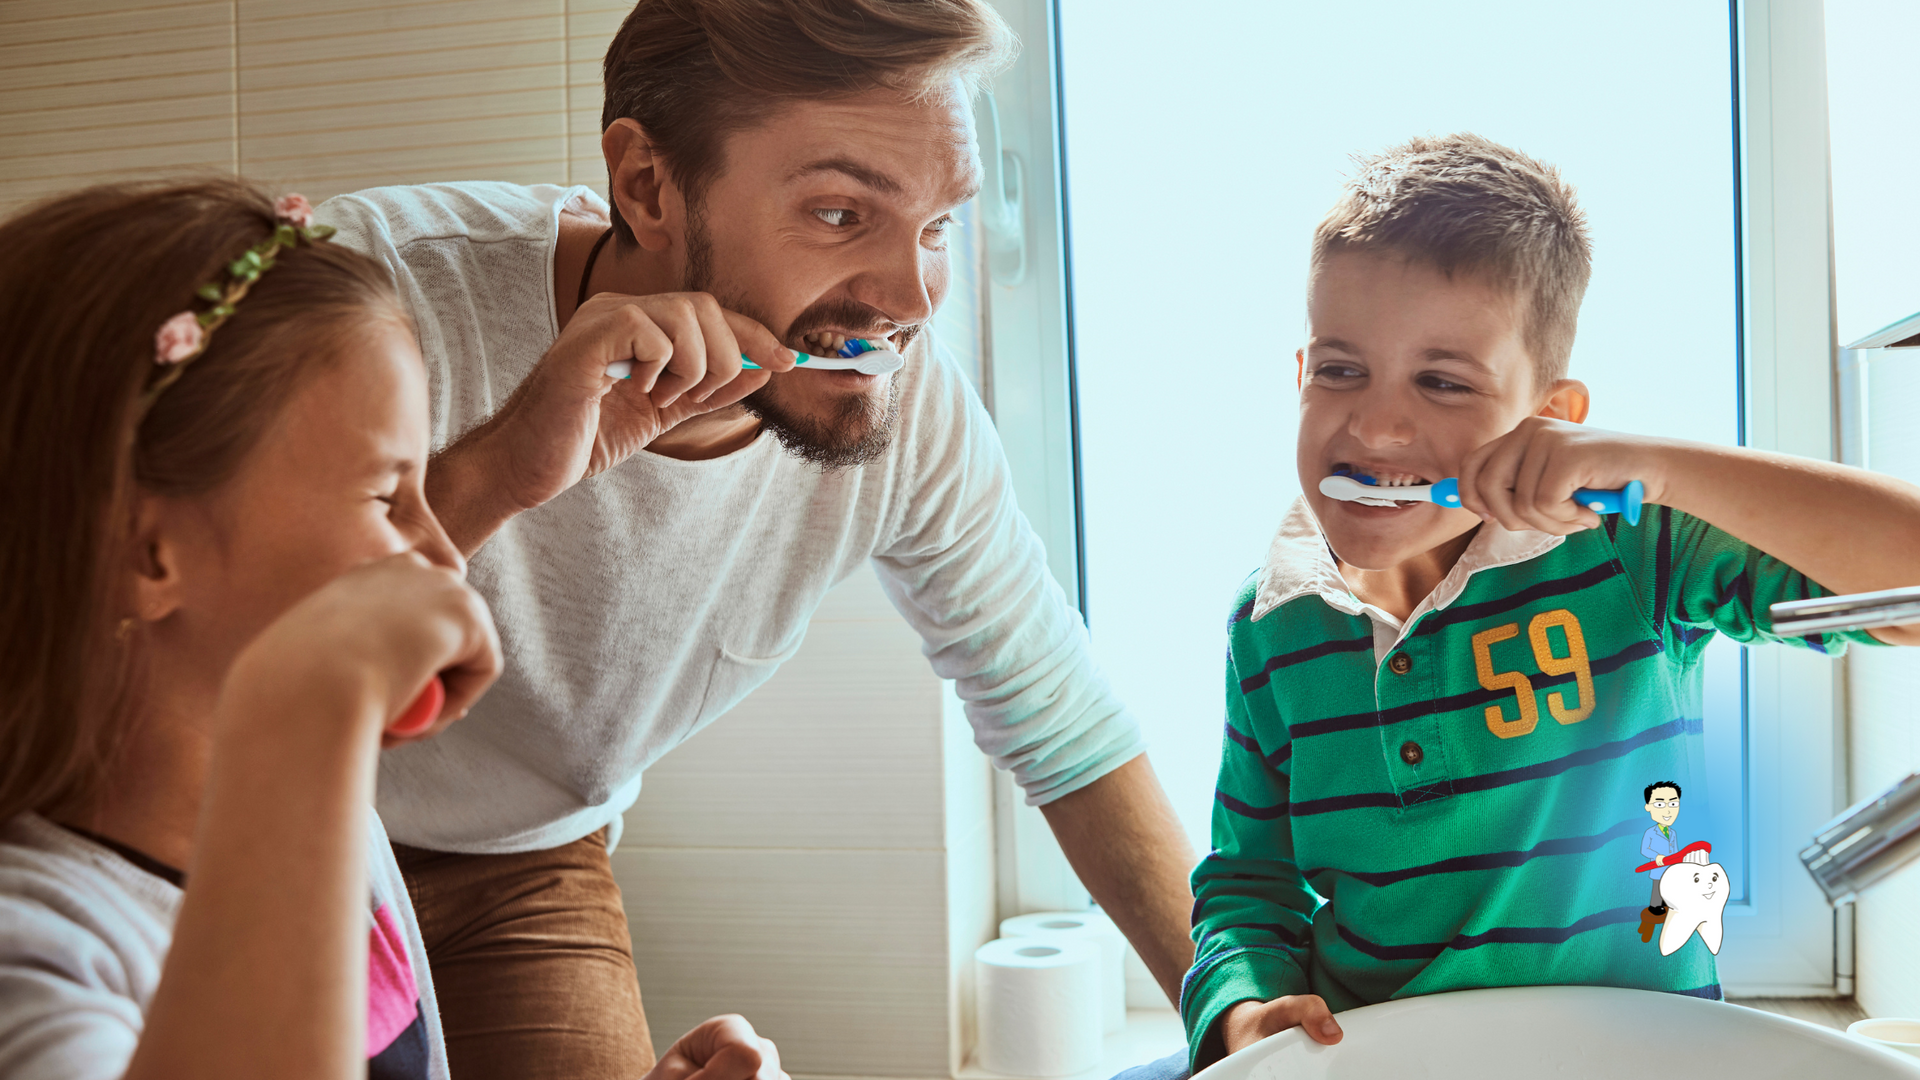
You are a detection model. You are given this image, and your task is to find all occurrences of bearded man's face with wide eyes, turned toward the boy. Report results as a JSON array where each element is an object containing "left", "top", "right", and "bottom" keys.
[{"left": 685, "top": 88, "right": 979, "bottom": 467}]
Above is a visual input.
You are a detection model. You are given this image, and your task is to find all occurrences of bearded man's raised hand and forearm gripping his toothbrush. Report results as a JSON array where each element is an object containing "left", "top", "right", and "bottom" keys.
[{"left": 426, "top": 292, "right": 797, "bottom": 555}]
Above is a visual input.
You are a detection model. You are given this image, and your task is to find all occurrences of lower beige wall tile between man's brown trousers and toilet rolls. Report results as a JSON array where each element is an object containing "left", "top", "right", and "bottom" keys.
[{"left": 614, "top": 847, "right": 948, "bottom": 1076}]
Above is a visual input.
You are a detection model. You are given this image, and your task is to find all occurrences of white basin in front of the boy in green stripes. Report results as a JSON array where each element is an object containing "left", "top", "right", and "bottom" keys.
[{"left": 1194, "top": 986, "right": 1920, "bottom": 1080}]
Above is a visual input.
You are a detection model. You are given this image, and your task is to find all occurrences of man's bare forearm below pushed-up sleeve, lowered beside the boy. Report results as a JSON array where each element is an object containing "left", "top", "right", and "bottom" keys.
[{"left": 1041, "top": 753, "right": 1198, "bottom": 1007}]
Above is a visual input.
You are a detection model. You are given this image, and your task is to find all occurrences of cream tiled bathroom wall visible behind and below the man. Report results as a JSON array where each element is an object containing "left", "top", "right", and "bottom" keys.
[{"left": 0, "top": 0, "right": 995, "bottom": 1076}]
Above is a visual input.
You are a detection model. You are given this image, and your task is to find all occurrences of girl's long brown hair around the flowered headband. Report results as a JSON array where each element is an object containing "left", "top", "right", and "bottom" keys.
[{"left": 0, "top": 179, "right": 407, "bottom": 821}]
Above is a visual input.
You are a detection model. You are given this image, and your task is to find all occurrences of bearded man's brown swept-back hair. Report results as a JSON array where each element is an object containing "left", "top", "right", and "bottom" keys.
[{"left": 601, "top": 0, "right": 1018, "bottom": 242}]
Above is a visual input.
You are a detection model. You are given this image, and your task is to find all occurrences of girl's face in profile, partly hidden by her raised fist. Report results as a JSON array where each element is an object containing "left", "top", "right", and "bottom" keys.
[{"left": 144, "top": 319, "right": 465, "bottom": 678}]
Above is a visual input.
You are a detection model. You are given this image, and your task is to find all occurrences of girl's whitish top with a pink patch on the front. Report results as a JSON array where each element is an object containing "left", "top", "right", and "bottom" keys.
[{"left": 0, "top": 813, "right": 447, "bottom": 1080}]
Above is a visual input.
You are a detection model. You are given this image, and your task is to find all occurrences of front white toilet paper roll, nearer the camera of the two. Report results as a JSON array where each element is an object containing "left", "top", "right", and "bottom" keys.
[{"left": 973, "top": 938, "right": 1102, "bottom": 1076}]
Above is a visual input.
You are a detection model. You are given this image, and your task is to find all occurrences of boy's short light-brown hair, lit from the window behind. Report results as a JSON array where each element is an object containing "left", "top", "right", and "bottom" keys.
[{"left": 1311, "top": 133, "right": 1594, "bottom": 386}]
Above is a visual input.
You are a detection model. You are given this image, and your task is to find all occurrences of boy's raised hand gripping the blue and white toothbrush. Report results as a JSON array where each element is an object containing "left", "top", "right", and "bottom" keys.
[{"left": 1459, "top": 417, "right": 1665, "bottom": 536}]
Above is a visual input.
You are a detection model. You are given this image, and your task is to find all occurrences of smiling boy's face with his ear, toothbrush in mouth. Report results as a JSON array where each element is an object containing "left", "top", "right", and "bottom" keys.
[{"left": 1298, "top": 252, "right": 1586, "bottom": 571}]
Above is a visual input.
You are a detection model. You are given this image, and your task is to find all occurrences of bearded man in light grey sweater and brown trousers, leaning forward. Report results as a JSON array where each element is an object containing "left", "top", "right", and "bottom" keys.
[{"left": 321, "top": 0, "right": 1194, "bottom": 1078}]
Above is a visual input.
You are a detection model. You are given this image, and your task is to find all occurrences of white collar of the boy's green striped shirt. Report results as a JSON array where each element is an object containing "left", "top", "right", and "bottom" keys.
[{"left": 1254, "top": 496, "right": 1565, "bottom": 630}]
